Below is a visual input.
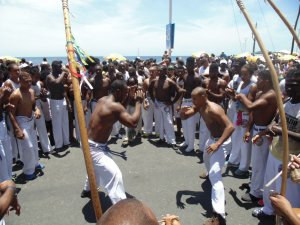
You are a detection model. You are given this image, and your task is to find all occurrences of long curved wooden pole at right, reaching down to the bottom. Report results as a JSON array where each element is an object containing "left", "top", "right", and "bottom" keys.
[{"left": 236, "top": 0, "right": 289, "bottom": 224}]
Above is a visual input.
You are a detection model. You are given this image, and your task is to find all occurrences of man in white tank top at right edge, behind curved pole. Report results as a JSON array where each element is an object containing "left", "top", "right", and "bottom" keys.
[{"left": 252, "top": 69, "right": 300, "bottom": 218}]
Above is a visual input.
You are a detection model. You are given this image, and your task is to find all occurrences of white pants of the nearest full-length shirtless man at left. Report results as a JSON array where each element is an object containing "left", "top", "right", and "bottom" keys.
[{"left": 16, "top": 116, "right": 39, "bottom": 175}]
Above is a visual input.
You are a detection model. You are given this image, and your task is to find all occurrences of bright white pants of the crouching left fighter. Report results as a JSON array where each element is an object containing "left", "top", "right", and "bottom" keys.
[{"left": 84, "top": 140, "right": 126, "bottom": 204}]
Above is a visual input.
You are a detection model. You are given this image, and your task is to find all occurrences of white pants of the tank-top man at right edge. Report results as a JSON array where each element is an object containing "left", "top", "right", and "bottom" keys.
[{"left": 263, "top": 152, "right": 300, "bottom": 215}]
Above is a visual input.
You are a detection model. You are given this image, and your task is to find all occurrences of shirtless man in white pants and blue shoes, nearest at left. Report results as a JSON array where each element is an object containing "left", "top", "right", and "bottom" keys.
[{"left": 9, "top": 72, "right": 44, "bottom": 180}]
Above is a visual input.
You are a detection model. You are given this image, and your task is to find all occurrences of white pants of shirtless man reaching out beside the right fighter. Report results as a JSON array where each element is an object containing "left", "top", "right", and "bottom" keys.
[{"left": 250, "top": 125, "right": 270, "bottom": 198}]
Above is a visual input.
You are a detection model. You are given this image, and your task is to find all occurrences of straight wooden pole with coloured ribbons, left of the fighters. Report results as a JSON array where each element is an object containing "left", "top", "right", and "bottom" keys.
[{"left": 62, "top": 0, "right": 102, "bottom": 221}]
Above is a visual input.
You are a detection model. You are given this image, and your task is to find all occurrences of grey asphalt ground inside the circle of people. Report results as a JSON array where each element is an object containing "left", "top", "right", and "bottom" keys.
[{"left": 5, "top": 134, "right": 274, "bottom": 225}]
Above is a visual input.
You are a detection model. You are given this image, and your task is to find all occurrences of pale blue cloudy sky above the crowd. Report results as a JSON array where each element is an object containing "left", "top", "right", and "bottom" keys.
[{"left": 0, "top": 0, "right": 300, "bottom": 56}]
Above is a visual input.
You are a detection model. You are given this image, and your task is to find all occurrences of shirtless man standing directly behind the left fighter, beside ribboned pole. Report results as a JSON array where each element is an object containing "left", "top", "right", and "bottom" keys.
[{"left": 90, "top": 64, "right": 110, "bottom": 112}]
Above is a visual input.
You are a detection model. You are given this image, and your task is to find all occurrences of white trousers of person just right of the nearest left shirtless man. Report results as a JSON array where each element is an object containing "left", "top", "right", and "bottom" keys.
[{"left": 35, "top": 99, "right": 51, "bottom": 152}]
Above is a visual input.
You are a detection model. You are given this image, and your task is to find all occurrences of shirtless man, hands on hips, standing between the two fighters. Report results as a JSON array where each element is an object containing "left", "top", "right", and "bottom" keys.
[{"left": 149, "top": 66, "right": 183, "bottom": 150}]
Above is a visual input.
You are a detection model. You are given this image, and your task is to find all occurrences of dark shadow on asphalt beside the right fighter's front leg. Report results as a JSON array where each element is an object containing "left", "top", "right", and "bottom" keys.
[{"left": 176, "top": 179, "right": 213, "bottom": 217}]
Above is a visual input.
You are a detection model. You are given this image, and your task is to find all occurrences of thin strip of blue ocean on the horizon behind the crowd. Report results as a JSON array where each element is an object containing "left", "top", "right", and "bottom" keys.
[{"left": 18, "top": 56, "right": 188, "bottom": 65}]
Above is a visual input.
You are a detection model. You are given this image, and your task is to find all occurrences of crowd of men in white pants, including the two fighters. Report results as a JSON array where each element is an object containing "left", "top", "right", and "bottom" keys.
[{"left": 0, "top": 54, "right": 300, "bottom": 224}]
